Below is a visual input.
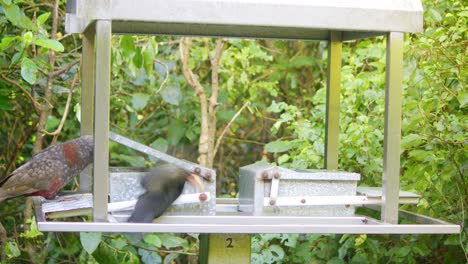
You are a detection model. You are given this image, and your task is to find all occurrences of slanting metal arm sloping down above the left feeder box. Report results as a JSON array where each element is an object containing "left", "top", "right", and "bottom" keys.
[{"left": 109, "top": 132, "right": 216, "bottom": 181}]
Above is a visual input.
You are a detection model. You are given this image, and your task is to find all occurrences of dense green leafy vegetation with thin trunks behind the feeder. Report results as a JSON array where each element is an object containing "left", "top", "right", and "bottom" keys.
[{"left": 0, "top": 0, "right": 468, "bottom": 263}]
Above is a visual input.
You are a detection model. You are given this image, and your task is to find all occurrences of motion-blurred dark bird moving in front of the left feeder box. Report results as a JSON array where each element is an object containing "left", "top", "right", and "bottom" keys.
[{"left": 128, "top": 164, "right": 203, "bottom": 223}]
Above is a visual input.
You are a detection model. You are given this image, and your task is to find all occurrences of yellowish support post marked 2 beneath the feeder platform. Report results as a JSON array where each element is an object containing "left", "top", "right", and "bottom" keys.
[{"left": 200, "top": 234, "right": 251, "bottom": 264}]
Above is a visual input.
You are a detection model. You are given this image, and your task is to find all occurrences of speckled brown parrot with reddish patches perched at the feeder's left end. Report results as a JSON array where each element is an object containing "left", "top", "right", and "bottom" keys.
[{"left": 0, "top": 136, "right": 94, "bottom": 201}]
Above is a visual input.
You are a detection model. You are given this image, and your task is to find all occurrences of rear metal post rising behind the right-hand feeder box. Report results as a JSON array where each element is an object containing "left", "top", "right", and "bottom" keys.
[{"left": 325, "top": 31, "right": 342, "bottom": 170}]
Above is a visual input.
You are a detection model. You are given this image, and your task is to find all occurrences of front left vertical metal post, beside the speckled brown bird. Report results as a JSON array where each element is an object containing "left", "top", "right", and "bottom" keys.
[{"left": 93, "top": 20, "right": 112, "bottom": 222}]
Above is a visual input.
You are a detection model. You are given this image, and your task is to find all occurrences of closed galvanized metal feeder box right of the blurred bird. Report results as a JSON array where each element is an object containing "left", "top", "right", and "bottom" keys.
[{"left": 239, "top": 163, "right": 361, "bottom": 216}]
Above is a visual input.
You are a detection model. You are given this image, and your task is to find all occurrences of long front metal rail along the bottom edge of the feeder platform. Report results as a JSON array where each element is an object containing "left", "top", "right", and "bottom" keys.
[{"left": 38, "top": 222, "right": 460, "bottom": 234}]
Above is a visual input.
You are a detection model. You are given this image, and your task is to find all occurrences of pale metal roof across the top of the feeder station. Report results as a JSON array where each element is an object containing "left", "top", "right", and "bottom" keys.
[{"left": 66, "top": 0, "right": 423, "bottom": 36}]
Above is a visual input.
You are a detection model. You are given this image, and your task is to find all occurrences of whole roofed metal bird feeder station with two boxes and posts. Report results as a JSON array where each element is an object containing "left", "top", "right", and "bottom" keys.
[{"left": 35, "top": 0, "right": 460, "bottom": 263}]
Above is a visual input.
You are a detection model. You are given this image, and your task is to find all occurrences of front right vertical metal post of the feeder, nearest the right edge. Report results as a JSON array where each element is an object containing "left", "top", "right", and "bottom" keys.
[{"left": 381, "top": 32, "right": 403, "bottom": 224}]
